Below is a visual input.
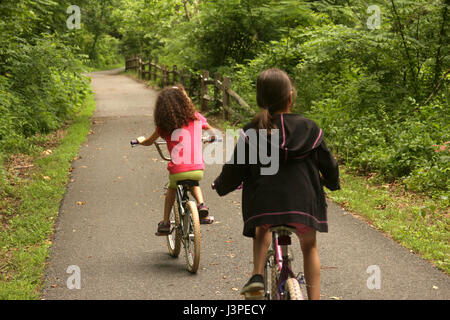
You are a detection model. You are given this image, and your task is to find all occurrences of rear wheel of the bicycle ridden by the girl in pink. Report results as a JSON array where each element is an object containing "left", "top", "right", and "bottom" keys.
[{"left": 184, "top": 201, "right": 201, "bottom": 273}]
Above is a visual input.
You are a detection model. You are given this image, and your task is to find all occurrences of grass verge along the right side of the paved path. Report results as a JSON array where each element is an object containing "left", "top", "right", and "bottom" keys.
[{"left": 328, "top": 167, "right": 450, "bottom": 274}]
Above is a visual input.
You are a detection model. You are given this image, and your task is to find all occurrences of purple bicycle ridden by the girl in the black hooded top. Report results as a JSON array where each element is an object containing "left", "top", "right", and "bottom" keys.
[{"left": 245, "top": 225, "right": 306, "bottom": 300}]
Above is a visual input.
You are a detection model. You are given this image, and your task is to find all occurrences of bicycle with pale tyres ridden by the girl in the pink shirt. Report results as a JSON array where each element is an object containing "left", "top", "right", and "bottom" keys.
[{"left": 131, "top": 137, "right": 219, "bottom": 273}]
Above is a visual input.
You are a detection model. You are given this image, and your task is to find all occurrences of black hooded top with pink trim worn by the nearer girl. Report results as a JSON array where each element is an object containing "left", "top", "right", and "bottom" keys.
[{"left": 214, "top": 114, "right": 340, "bottom": 237}]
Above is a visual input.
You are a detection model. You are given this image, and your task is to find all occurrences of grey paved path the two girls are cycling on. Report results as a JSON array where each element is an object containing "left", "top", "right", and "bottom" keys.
[{"left": 42, "top": 70, "right": 450, "bottom": 299}]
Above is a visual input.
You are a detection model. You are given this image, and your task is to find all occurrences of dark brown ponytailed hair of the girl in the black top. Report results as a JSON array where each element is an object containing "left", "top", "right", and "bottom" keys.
[{"left": 252, "top": 68, "right": 297, "bottom": 132}]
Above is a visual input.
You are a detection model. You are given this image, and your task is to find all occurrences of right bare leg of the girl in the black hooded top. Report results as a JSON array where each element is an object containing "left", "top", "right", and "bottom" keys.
[{"left": 299, "top": 229, "right": 320, "bottom": 300}]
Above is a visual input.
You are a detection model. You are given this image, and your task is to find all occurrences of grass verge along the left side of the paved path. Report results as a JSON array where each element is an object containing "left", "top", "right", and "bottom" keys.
[{"left": 0, "top": 94, "right": 95, "bottom": 300}]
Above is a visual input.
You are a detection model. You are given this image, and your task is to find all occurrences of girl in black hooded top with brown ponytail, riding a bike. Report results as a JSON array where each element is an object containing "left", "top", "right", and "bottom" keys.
[{"left": 214, "top": 69, "right": 340, "bottom": 299}]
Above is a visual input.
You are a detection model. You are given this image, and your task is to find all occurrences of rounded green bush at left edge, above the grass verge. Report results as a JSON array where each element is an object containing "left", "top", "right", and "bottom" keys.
[{"left": 0, "top": 36, "right": 88, "bottom": 151}]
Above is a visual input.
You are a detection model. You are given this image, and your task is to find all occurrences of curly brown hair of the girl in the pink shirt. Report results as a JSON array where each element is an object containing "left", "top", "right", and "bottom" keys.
[{"left": 154, "top": 85, "right": 197, "bottom": 136}]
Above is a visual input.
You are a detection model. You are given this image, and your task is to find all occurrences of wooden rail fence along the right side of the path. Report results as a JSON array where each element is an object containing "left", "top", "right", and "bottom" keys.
[{"left": 125, "top": 57, "right": 255, "bottom": 120}]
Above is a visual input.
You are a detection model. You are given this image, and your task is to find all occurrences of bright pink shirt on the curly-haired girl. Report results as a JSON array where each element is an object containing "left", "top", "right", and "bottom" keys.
[{"left": 159, "top": 112, "right": 208, "bottom": 174}]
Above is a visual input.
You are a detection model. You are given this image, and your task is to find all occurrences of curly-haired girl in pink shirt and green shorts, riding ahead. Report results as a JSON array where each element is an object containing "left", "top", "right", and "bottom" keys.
[{"left": 138, "top": 85, "right": 214, "bottom": 236}]
